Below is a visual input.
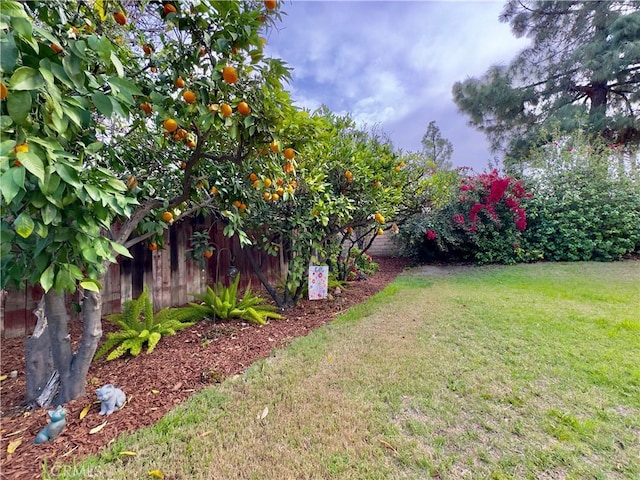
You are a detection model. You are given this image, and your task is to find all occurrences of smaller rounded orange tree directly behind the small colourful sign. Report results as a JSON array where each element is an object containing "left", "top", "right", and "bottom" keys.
[{"left": 228, "top": 108, "right": 405, "bottom": 306}]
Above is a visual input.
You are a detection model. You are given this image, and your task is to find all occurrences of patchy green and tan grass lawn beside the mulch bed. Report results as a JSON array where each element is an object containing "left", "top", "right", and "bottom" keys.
[{"left": 54, "top": 262, "right": 640, "bottom": 480}]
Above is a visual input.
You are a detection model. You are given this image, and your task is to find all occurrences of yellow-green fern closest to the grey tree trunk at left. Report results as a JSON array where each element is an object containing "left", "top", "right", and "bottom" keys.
[{"left": 95, "top": 285, "right": 202, "bottom": 360}]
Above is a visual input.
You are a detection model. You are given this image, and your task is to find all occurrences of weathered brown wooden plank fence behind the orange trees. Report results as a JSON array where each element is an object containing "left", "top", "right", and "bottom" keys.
[{"left": 0, "top": 218, "right": 281, "bottom": 338}]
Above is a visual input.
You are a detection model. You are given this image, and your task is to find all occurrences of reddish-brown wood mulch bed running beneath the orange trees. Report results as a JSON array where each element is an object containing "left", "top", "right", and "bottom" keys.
[{"left": 0, "top": 258, "right": 407, "bottom": 480}]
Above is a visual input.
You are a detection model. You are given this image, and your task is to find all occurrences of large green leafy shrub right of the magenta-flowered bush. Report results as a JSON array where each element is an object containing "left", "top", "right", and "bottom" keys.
[{"left": 524, "top": 132, "right": 640, "bottom": 261}]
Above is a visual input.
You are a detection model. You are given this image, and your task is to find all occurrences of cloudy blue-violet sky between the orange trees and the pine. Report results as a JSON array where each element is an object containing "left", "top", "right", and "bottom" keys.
[{"left": 265, "top": 0, "right": 528, "bottom": 172}]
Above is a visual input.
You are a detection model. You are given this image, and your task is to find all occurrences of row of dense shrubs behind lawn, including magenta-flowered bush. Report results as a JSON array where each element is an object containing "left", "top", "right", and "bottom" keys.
[{"left": 399, "top": 129, "right": 640, "bottom": 264}]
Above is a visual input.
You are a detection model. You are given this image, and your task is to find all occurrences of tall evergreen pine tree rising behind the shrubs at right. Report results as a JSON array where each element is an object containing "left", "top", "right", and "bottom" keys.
[{"left": 453, "top": 0, "right": 640, "bottom": 161}]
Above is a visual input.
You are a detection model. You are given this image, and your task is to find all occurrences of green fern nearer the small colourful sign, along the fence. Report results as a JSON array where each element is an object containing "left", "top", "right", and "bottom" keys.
[{"left": 185, "top": 275, "right": 283, "bottom": 325}]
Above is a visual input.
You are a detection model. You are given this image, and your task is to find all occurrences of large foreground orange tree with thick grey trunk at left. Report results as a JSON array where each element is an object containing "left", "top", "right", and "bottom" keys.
[{"left": 0, "top": 0, "right": 289, "bottom": 404}]
